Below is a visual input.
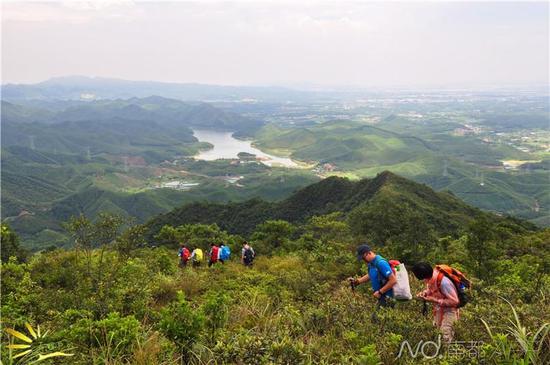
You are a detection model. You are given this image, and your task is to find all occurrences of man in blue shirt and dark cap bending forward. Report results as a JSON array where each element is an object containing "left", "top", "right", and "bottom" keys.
[{"left": 349, "top": 245, "right": 397, "bottom": 308}]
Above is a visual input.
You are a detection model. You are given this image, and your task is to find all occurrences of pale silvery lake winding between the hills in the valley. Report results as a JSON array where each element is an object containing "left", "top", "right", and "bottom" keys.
[{"left": 193, "top": 129, "right": 298, "bottom": 167}]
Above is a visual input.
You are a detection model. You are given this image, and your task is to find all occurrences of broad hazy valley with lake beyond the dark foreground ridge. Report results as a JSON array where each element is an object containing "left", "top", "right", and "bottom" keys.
[{"left": 2, "top": 79, "right": 550, "bottom": 249}]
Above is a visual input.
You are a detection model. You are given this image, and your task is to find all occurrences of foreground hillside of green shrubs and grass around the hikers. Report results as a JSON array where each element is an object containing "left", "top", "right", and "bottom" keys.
[{"left": 1, "top": 186, "right": 550, "bottom": 365}]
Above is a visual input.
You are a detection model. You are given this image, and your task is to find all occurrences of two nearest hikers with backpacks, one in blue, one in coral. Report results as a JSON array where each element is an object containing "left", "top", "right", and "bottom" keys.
[{"left": 349, "top": 244, "right": 471, "bottom": 343}]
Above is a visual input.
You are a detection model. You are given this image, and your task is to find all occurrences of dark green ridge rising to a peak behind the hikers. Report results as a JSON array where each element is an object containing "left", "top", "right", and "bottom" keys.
[{"left": 149, "top": 172, "right": 533, "bottom": 237}]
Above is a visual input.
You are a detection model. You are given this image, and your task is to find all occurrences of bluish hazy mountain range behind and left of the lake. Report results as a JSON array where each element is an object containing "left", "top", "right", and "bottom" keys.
[{"left": 2, "top": 96, "right": 264, "bottom": 161}]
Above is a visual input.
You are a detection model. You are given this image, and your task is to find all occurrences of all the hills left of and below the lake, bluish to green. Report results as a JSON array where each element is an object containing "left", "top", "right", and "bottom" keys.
[{"left": 2, "top": 97, "right": 318, "bottom": 250}]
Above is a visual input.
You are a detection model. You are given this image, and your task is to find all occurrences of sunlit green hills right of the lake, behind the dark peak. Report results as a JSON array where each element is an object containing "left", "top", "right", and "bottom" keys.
[{"left": 256, "top": 114, "right": 550, "bottom": 223}]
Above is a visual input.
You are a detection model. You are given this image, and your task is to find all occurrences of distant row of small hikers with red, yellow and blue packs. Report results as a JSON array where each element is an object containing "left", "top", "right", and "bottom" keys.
[{"left": 178, "top": 241, "right": 256, "bottom": 267}]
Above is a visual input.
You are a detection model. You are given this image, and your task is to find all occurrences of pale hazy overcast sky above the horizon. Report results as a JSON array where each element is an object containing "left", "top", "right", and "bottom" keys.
[{"left": 2, "top": 1, "right": 549, "bottom": 86}]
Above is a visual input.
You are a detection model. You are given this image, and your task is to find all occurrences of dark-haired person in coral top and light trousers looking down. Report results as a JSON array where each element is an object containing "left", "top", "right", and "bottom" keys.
[{"left": 412, "top": 262, "right": 460, "bottom": 343}]
